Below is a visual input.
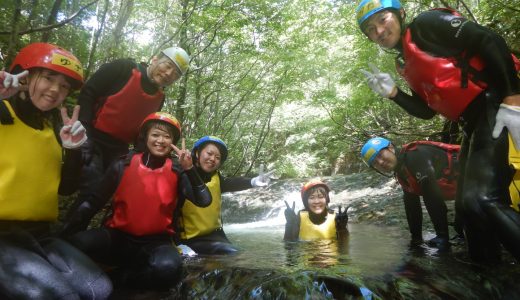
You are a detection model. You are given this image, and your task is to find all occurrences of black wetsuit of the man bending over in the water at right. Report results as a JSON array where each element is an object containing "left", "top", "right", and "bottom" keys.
[{"left": 395, "top": 145, "right": 455, "bottom": 242}]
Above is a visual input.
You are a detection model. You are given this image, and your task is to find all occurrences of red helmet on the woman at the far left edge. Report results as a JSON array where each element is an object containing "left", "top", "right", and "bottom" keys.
[{"left": 9, "top": 43, "right": 83, "bottom": 89}]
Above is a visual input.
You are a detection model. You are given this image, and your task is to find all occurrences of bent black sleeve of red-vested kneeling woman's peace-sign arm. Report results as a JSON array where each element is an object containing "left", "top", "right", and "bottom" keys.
[{"left": 180, "top": 168, "right": 211, "bottom": 207}]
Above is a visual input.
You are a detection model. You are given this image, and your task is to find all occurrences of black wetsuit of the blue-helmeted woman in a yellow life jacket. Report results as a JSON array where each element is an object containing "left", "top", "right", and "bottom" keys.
[{"left": 176, "top": 168, "right": 253, "bottom": 254}]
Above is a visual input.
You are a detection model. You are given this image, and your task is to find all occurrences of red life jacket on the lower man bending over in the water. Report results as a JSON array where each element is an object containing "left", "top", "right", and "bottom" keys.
[{"left": 396, "top": 141, "right": 460, "bottom": 200}]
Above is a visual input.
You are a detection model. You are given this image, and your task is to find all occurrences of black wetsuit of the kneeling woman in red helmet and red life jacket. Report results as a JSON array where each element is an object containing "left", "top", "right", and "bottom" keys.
[{"left": 63, "top": 152, "right": 211, "bottom": 289}]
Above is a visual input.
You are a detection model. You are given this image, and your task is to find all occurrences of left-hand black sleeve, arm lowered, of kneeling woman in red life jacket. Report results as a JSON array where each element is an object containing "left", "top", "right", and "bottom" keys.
[{"left": 59, "top": 159, "right": 125, "bottom": 237}]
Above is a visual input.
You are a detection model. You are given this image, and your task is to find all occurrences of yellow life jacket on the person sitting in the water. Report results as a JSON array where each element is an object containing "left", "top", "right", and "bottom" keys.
[{"left": 299, "top": 210, "right": 336, "bottom": 241}]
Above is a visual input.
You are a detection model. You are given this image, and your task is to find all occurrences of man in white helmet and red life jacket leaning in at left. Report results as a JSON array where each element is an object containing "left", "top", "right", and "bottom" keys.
[{"left": 74, "top": 47, "right": 190, "bottom": 230}]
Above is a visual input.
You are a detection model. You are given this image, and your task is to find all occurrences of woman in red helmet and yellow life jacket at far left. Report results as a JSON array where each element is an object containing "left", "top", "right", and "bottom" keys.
[{"left": 0, "top": 43, "right": 112, "bottom": 299}]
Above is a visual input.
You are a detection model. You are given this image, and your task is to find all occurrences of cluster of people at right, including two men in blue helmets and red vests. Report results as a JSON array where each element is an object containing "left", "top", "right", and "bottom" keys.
[{"left": 356, "top": 0, "right": 520, "bottom": 262}]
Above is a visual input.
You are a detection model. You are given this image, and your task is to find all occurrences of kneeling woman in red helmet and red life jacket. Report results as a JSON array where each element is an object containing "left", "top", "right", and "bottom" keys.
[{"left": 62, "top": 112, "right": 211, "bottom": 289}]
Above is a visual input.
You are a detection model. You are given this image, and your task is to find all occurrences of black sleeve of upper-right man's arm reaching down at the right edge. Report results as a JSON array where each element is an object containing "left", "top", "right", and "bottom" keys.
[{"left": 412, "top": 11, "right": 520, "bottom": 99}]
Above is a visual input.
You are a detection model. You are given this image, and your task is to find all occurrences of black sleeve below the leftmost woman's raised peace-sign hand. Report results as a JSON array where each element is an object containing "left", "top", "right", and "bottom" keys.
[{"left": 58, "top": 149, "right": 82, "bottom": 196}]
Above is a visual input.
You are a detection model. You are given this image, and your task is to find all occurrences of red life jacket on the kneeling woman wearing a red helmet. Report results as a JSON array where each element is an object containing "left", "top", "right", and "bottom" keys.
[{"left": 106, "top": 153, "right": 178, "bottom": 236}]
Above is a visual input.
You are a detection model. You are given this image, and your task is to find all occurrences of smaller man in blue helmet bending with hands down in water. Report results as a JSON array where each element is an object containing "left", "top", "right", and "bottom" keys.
[{"left": 361, "top": 137, "right": 460, "bottom": 250}]
